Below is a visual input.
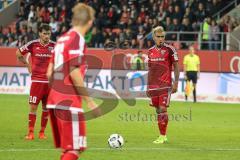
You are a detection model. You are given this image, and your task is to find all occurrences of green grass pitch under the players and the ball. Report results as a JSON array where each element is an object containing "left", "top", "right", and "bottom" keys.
[{"left": 0, "top": 95, "right": 240, "bottom": 160}]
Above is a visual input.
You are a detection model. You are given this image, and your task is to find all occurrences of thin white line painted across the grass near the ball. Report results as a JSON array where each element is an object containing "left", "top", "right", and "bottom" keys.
[{"left": 0, "top": 147, "right": 240, "bottom": 152}]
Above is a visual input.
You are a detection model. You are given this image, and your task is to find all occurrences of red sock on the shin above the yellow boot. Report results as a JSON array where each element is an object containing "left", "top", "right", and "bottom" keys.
[{"left": 158, "top": 112, "right": 168, "bottom": 135}]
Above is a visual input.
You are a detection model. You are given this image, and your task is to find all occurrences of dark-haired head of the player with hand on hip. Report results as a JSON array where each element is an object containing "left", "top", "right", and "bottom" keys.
[{"left": 38, "top": 23, "right": 51, "bottom": 43}]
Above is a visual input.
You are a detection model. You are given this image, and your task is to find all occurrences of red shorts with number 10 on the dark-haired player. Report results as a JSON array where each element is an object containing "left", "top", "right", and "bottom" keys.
[{"left": 29, "top": 82, "right": 49, "bottom": 105}]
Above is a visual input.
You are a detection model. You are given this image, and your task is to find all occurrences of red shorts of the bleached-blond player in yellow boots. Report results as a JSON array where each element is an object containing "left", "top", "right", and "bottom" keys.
[{"left": 150, "top": 89, "right": 171, "bottom": 107}]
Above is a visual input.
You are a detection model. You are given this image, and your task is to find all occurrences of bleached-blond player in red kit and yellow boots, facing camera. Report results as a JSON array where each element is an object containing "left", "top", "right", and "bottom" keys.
[{"left": 147, "top": 26, "right": 179, "bottom": 144}]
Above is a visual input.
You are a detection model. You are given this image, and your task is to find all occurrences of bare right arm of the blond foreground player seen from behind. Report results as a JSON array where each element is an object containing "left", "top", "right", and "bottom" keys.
[{"left": 70, "top": 66, "right": 101, "bottom": 116}]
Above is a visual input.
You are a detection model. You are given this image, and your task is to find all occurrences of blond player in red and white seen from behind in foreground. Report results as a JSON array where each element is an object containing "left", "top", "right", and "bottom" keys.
[{"left": 47, "top": 3, "right": 100, "bottom": 160}]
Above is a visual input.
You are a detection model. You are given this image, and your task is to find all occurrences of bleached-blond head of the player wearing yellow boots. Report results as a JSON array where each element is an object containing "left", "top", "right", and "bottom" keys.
[{"left": 152, "top": 26, "right": 165, "bottom": 46}]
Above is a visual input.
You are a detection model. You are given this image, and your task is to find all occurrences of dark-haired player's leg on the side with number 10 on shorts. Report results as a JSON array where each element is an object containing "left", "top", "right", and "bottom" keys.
[{"left": 25, "top": 82, "right": 40, "bottom": 140}]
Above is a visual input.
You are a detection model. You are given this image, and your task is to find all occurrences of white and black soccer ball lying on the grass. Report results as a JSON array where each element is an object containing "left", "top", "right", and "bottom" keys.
[{"left": 108, "top": 134, "right": 124, "bottom": 148}]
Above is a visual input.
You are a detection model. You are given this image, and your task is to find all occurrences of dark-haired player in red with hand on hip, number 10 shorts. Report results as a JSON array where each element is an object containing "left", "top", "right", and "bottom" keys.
[{"left": 16, "top": 24, "right": 55, "bottom": 140}]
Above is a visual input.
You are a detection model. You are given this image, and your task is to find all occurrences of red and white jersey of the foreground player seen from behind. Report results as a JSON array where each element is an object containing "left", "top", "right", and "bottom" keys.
[{"left": 47, "top": 29, "right": 87, "bottom": 110}]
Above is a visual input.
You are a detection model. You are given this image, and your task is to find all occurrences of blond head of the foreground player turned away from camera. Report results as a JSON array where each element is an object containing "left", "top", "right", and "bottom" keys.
[{"left": 72, "top": 3, "right": 95, "bottom": 31}]
